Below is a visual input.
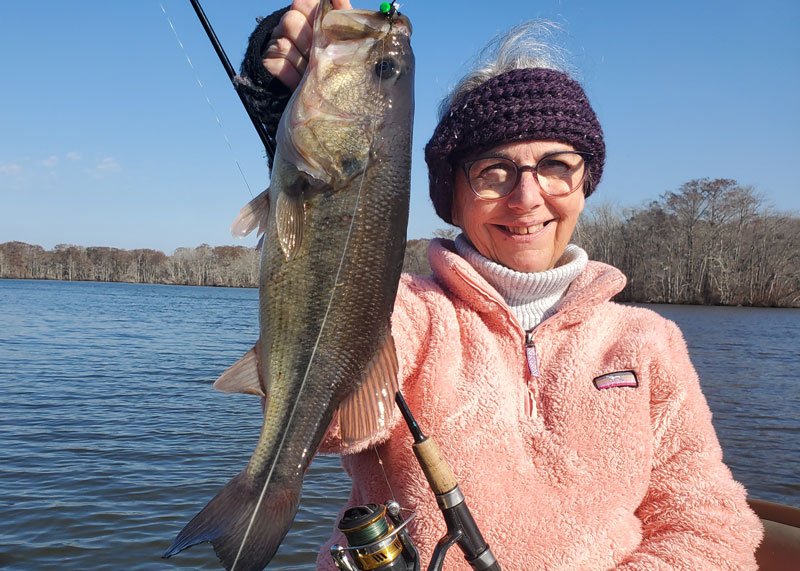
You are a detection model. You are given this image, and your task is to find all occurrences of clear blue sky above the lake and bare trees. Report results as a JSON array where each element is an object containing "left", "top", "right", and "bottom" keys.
[{"left": 0, "top": 0, "right": 800, "bottom": 254}]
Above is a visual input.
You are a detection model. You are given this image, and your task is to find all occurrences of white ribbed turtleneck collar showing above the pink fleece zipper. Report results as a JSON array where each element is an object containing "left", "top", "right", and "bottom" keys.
[{"left": 455, "top": 234, "right": 589, "bottom": 331}]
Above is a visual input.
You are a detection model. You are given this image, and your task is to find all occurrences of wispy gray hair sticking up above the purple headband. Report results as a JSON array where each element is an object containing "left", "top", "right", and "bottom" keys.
[{"left": 439, "top": 20, "right": 574, "bottom": 120}]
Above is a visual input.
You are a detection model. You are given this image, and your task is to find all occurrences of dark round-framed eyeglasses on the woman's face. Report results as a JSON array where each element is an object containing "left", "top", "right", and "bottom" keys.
[{"left": 464, "top": 151, "right": 594, "bottom": 200}]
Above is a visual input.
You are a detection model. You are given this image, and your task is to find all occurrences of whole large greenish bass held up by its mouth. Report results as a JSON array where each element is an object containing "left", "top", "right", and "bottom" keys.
[{"left": 163, "top": 0, "right": 414, "bottom": 570}]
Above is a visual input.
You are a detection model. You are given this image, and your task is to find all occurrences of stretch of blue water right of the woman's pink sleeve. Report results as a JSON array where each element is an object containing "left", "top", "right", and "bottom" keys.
[{"left": 636, "top": 305, "right": 800, "bottom": 505}]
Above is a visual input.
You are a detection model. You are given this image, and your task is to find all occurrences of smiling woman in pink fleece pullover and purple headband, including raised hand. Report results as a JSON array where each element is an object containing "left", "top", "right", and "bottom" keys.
[{"left": 240, "top": 0, "right": 762, "bottom": 571}]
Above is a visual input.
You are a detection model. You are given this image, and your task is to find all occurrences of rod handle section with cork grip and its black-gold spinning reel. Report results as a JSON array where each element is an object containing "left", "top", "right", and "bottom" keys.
[{"left": 331, "top": 391, "right": 500, "bottom": 571}]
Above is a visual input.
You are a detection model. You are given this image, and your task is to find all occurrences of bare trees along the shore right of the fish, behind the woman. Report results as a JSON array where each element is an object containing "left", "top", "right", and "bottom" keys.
[{"left": 405, "top": 179, "right": 800, "bottom": 307}]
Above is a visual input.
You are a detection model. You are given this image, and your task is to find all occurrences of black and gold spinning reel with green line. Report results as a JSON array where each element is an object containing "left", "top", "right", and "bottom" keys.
[{"left": 331, "top": 502, "right": 419, "bottom": 571}]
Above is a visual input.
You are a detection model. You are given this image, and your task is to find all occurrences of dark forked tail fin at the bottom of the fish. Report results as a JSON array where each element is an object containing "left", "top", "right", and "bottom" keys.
[{"left": 162, "top": 472, "right": 303, "bottom": 571}]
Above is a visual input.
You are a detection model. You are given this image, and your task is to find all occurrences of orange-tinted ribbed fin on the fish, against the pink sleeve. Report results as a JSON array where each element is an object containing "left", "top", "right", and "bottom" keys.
[{"left": 339, "top": 331, "right": 398, "bottom": 447}]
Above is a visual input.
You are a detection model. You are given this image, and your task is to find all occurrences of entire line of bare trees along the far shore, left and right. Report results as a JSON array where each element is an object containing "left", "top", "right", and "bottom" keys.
[{"left": 0, "top": 179, "right": 800, "bottom": 307}]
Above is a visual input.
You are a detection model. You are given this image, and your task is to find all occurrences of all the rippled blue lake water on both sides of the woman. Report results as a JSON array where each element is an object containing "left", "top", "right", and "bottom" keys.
[{"left": 0, "top": 280, "right": 800, "bottom": 570}]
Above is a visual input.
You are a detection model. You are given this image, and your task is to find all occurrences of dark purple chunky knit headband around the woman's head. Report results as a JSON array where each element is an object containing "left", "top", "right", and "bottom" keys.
[{"left": 425, "top": 68, "right": 606, "bottom": 224}]
